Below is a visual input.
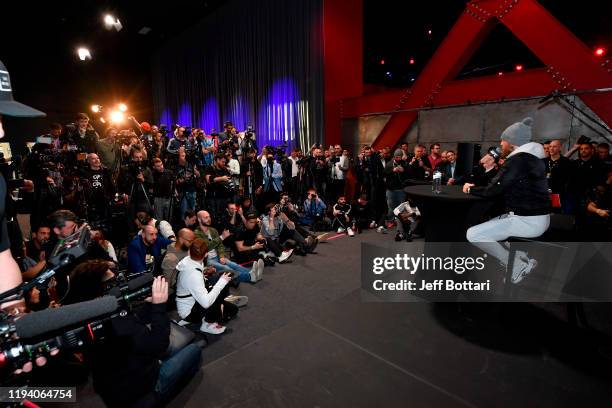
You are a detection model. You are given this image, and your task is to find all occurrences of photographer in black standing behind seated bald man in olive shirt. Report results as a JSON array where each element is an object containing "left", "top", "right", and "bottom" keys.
[{"left": 204, "top": 153, "right": 236, "bottom": 219}]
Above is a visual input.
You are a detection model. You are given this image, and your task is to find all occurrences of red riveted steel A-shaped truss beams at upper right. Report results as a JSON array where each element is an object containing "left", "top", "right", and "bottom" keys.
[{"left": 342, "top": 0, "right": 612, "bottom": 147}]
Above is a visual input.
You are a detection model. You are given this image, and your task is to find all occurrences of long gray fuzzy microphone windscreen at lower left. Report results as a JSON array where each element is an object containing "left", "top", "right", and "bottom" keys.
[{"left": 15, "top": 296, "right": 118, "bottom": 339}]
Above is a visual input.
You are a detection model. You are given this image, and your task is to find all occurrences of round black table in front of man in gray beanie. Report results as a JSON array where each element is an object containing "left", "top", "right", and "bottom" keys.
[{"left": 404, "top": 185, "right": 492, "bottom": 242}]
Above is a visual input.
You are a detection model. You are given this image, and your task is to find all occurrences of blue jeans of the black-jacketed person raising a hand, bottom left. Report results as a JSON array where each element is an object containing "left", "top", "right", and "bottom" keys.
[{"left": 155, "top": 344, "right": 202, "bottom": 399}]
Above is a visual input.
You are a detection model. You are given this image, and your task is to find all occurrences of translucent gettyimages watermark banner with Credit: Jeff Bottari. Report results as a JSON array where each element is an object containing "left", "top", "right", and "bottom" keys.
[{"left": 361, "top": 242, "right": 612, "bottom": 302}]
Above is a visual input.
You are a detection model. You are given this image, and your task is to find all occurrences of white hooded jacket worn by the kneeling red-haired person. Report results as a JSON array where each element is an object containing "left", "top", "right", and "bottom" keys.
[{"left": 176, "top": 256, "right": 227, "bottom": 319}]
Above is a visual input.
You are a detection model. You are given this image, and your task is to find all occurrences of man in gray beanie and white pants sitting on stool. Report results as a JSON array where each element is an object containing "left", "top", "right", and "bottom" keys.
[{"left": 463, "top": 117, "right": 551, "bottom": 283}]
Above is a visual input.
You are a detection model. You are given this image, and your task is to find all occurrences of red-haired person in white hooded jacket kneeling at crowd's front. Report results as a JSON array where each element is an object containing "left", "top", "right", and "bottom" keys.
[{"left": 176, "top": 238, "right": 238, "bottom": 334}]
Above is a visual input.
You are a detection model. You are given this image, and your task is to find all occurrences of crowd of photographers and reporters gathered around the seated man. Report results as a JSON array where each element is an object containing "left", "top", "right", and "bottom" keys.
[{"left": 4, "top": 110, "right": 612, "bottom": 405}]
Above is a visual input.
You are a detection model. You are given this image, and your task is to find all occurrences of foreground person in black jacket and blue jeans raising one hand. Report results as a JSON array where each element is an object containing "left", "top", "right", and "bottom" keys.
[{"left": 65, "top": 264, "right": 202, "bottom": 407}]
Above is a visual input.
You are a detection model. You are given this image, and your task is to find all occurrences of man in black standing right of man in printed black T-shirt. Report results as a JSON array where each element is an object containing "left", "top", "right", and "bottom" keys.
[{"left": 117, "top": 146, "right": 153, "bottom": 214}]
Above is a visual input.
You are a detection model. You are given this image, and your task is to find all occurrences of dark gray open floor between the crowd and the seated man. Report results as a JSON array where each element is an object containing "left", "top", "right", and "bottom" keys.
[{"left": 58, "top": 231, "right": 612, "bottom": 408}]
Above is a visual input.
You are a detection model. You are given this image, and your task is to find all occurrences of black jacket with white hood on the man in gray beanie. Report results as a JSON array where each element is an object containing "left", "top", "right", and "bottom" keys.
[{"left": 470, "top": 142, "right": 551, "bottom": 216}]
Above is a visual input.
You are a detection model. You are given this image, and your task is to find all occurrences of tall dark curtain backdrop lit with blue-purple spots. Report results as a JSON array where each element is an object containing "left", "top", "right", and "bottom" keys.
[{"left": 152, "top": 0, "right": 326, "bottom": 148}]
